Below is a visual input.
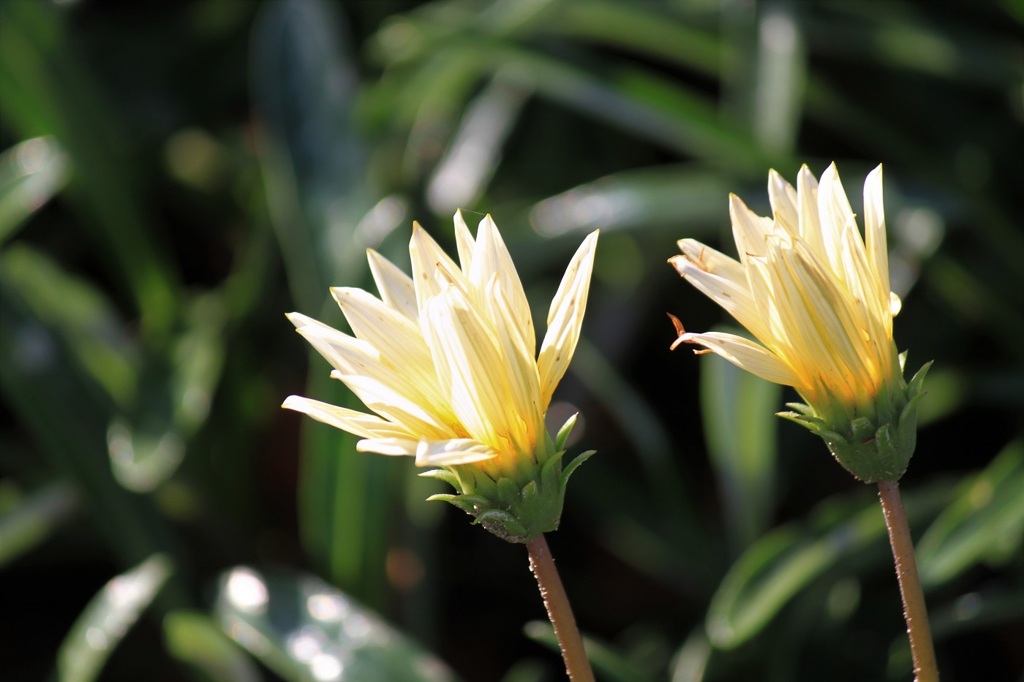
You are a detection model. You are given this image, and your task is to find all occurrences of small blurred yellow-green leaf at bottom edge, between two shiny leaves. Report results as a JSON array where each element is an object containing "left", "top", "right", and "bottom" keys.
[{"left": 164, "top": 610, "right": 261, "bottom": 682}]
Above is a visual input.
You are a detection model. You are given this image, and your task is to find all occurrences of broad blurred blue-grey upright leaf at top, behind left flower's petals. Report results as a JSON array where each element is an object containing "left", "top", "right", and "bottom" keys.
[{"left": 250, "top": 0, "right": 374, "bottom": 305}]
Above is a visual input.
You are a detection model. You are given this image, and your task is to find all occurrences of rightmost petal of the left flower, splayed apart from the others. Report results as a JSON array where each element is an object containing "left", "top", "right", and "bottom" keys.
[{"left": 537, "top": 230, "right": 598, "bottom": 412}]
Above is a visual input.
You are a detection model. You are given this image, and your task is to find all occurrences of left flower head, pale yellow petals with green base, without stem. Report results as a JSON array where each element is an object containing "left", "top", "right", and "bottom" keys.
[{"left": 284, "top": 213, "right": 597, "bottom": 542}]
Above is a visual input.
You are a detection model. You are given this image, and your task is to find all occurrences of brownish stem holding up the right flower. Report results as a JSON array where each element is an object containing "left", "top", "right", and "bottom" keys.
[{"left": 879, "top": 480, "right": 939, "bottom": 682}]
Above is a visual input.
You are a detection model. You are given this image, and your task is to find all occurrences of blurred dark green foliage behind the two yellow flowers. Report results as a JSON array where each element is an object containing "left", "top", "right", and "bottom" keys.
[{"left": 0, "top": 0, "right": 1024, "bottom": 682}]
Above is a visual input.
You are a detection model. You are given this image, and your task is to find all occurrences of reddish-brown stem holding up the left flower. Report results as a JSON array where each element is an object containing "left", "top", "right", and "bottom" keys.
[{"left": 526, "top": 535, "right": 594, "bottom": 682}]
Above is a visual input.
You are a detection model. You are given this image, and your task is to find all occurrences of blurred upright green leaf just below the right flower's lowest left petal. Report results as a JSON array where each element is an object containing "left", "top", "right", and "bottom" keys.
[{"left": 700, "top": 342, "right": 782, "bottom": 550}]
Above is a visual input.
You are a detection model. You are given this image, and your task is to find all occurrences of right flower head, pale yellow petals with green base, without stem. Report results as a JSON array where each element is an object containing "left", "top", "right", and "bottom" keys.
[{"left": 669, "top": 164, "right": 927, "bottom": 482}]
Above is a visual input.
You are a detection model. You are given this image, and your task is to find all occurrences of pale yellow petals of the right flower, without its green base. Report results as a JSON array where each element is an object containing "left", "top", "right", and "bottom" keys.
[{"left": 670, "top": 164, "right": 899, "bottom": 411}]
